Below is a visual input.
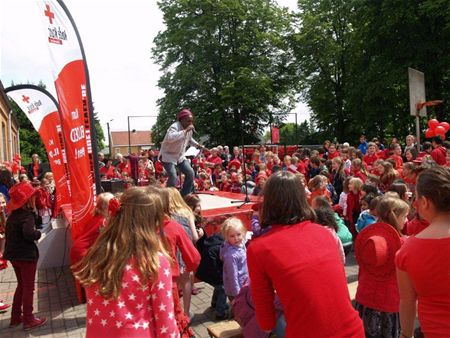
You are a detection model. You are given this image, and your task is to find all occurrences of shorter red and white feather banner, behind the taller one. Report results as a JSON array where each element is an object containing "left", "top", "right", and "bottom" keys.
[{"left": 6, "top": 85, "right": 72, "bottom": 223}]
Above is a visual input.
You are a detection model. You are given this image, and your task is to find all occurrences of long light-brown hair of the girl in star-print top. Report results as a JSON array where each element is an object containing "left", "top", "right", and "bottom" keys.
[{"left": 72, "top": 188, "right": 171, "bottom": 299}]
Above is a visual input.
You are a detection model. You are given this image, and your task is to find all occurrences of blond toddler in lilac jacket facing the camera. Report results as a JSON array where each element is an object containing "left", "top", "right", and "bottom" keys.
[{"left": 220, "top": 217, "right": 248, "bottom": 300}]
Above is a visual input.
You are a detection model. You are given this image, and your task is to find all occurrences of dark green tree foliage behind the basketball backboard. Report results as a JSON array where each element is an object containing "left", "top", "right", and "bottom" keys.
[{"left": 291, "top": 0, "right": 450, "bottom": 141}]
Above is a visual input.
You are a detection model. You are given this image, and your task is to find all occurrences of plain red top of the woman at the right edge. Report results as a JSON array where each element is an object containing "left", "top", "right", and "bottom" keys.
[{"left": 395, "top": 237, "right": 450, "bottom": 338}]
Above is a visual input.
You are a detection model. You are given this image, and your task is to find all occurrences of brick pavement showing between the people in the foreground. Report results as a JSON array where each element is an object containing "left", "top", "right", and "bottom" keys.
[{"left": 0, "top": 253, "right": 358, "bottom": 338}]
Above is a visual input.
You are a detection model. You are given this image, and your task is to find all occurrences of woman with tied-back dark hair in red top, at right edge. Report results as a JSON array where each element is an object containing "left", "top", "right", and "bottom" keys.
[{"left": 395, "top": 166, "right": 450, "bottom": 338}]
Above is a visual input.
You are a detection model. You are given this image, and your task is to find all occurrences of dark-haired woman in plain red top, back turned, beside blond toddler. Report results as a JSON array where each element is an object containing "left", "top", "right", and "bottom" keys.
[{"left": 247, "top": 172, "right": 364, "bottom": 338}]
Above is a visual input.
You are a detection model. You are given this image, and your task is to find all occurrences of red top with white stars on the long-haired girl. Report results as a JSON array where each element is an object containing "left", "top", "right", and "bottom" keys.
[{"left": 86, "top": 254, "right": 180, "bottom": 338}]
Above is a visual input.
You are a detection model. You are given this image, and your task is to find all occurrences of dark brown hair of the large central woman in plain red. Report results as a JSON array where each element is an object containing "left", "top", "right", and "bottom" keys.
[{"left": 260, "top": 171, "right": 316, "bottom": 227}]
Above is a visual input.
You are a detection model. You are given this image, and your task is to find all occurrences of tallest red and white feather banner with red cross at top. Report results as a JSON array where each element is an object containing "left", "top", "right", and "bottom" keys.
[{"left": 38, "top": 0, "right": 96, "bottom": 239}]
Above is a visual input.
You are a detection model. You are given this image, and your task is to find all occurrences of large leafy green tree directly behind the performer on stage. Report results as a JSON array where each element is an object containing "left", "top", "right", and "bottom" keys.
[{"left": 152, "top": 0, "right": 297, "bottom": 145}]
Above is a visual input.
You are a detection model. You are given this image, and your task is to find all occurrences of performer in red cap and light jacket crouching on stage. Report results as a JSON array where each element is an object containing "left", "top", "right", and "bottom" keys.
[{"left": 159, "top": 109, "right": 204, "bottom": 196}]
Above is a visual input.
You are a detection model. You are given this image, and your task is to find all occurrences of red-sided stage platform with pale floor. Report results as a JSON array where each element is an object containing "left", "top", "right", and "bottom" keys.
[{"left": 197, "top": 191, "right": 260, "bottom": 235}]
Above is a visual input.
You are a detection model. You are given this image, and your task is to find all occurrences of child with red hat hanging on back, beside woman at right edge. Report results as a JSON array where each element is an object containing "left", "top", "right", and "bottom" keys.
[{"left": 355, "top": 197, "right": 409, "bottom": 338}]
